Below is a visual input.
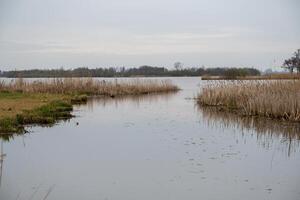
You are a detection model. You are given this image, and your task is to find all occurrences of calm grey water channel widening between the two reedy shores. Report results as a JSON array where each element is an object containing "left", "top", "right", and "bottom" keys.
[{"left": 0, "top": 78, "right": 300, "bottom": 200}]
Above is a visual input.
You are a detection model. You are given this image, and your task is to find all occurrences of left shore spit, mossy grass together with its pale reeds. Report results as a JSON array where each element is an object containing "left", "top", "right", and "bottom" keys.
[{"left": 0, "top": 78, "right": 179, "bottom": 134}]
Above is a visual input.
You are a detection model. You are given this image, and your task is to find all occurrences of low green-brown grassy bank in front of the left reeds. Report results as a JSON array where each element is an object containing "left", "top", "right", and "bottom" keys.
[{"left": 0, "top": 91, "right": 86, "bottom": 134}]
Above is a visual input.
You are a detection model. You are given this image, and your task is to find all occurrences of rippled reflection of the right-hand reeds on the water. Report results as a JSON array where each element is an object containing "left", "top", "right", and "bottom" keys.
[{"left": 197, "top": 105, "right": 300, "bottom": 156}]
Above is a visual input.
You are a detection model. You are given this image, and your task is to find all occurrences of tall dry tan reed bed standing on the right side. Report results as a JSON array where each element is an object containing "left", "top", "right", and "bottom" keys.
[{"left": 198, "top": 80, "right": 300, "bottom": 122}]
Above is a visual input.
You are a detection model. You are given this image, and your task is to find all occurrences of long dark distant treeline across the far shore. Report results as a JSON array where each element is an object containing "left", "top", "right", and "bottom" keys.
[{"left": 0, "top": 66, "right": 260, "bottom": 78}]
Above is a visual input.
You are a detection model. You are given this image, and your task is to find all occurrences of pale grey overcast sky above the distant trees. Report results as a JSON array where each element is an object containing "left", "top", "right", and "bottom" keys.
[{"left": 0, "top": 0, "right": 300, "bottom": 70}]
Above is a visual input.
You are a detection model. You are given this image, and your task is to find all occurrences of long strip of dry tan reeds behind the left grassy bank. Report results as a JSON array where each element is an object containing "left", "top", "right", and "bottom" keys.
[{"left": 0, "top": 78, "right": 178, "bottom": 96}]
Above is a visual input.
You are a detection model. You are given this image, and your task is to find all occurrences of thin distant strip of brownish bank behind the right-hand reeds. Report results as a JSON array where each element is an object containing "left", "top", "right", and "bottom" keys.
[{"left": 201, "top": 74, "right": 300, "bottom": 80}]
